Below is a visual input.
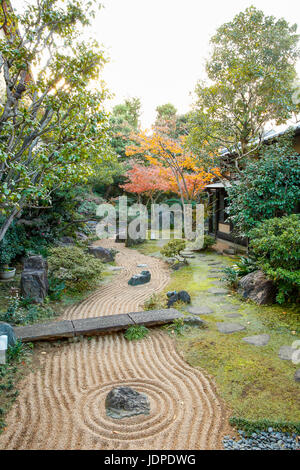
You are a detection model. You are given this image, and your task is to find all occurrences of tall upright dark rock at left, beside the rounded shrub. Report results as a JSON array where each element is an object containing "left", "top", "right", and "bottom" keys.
[{"left": 21, "top": 255, "right": 49, "bottom": 303}]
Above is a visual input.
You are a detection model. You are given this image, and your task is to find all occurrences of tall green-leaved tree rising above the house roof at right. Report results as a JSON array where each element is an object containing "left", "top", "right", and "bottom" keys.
[{"left": 189, "top": 7, "right": 299, "bottom": 176}]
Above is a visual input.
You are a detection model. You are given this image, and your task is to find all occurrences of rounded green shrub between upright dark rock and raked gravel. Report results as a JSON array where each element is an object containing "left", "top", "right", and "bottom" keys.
[{"left": 48, "top": 246, "right": 103, "bottom": 292}]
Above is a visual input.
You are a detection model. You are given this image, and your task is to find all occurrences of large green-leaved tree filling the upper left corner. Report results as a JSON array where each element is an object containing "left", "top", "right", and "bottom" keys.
[{"left": 0, "top": 0, "right": 111, "bottom": 240}]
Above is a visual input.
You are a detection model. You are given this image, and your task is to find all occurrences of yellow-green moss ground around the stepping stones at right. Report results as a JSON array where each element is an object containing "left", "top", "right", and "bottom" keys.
[{"left": 138, "top": 241, "right": 300, "bottom": 423}]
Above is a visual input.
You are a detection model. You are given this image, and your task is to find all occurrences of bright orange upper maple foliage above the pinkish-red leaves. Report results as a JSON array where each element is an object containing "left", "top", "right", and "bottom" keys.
[{"left": 126, "top": 128, "right": 219, "bottom": 204}]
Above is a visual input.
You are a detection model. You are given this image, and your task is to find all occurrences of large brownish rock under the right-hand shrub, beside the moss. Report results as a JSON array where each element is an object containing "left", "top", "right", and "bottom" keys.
[{"left": 238, "top": 270, "right": 276, "bottom": 305}]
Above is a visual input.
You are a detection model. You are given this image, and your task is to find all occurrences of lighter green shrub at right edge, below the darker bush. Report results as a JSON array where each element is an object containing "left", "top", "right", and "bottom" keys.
[{"left": 250, "top": 214, "right": 300, "bottom": 303}]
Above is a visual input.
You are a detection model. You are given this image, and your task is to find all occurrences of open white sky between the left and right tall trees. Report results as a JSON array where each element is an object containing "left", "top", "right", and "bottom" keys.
[{"left": 90, "top": 0, "right": 300, "bottom": 128}]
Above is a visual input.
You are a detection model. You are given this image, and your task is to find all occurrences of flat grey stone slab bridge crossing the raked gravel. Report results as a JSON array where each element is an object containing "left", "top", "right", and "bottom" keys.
[{"left": 14, "top": 308, "right": 183, "bottom": 343}]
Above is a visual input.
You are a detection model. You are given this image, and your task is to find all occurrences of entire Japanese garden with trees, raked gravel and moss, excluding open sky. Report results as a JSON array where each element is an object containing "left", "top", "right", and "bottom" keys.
[{"left": 0, "top": 0, "right": 300, "bottom": 455}]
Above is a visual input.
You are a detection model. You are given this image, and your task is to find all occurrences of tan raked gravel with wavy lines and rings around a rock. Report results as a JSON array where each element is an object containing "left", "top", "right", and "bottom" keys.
[{"left": 0, "top": 241, "right": 228, "bottom": 450}]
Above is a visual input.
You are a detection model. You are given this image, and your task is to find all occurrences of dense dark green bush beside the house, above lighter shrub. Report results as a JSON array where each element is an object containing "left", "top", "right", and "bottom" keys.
[{"left": 228, "top": 134, "right": 300, "bottom": 236}]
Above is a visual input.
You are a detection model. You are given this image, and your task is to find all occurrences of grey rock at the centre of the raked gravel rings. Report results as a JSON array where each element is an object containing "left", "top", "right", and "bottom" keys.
[{"left": 105, "top": 387, "right": 150, "bottom": 419}]
